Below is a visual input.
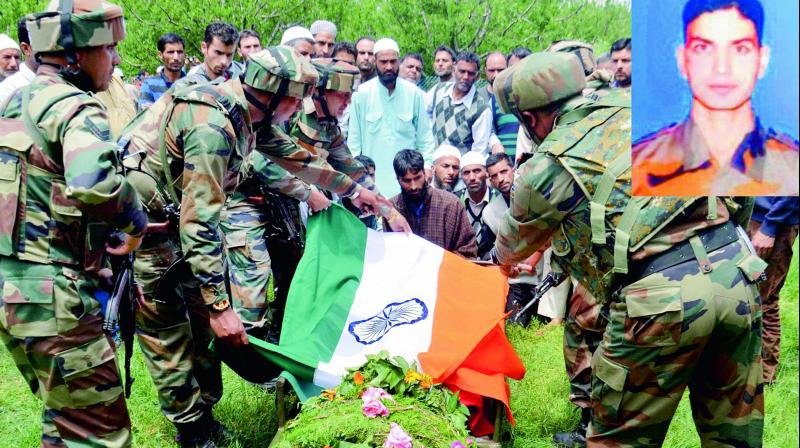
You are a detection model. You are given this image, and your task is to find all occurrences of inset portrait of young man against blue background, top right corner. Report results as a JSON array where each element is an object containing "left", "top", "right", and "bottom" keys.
[{"left": 631, "top": 0, "right": 800, "bottom": 196}]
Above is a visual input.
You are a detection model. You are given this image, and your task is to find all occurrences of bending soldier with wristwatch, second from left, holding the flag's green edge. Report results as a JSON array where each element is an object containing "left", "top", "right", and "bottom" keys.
[{"left": 120, "top": 47, "right": 392, "bottom": 447}]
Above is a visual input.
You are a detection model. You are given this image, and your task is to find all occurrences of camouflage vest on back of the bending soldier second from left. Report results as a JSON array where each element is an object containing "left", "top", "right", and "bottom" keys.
[{"left": 117, "top": 79, "right": 247, "bottom": 221}]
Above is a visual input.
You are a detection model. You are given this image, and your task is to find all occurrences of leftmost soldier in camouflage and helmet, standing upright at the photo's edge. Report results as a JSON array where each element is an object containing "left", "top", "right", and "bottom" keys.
[{"left": 0, "top": 0, "right": 147, "bottom": 447}]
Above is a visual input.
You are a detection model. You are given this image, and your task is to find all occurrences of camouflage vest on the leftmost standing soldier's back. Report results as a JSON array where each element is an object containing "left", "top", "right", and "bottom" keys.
[{"left": 0, "top": 84, "right": 110, "bottom": 271}]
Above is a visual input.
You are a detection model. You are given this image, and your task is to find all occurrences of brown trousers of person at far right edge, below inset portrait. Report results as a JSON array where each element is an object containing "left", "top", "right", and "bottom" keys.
[{"left": 748, "top": 221, "right": 798, "bottom": 383}]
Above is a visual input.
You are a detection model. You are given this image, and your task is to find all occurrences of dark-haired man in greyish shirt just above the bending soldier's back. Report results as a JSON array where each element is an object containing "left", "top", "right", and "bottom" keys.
[{"left": 182, "top": 22, "right": 239, "bottom": 89}]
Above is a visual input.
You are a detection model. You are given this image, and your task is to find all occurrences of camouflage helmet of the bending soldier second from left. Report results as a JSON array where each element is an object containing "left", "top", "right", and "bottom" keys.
[{"left": 244, "top": 46, "right": 319, "bottom": 98}]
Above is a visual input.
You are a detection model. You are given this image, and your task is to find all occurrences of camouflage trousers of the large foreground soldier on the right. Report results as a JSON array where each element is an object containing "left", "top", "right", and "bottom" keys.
[{"left": 587, "top": 237, "right": 764, "bottom": 447}]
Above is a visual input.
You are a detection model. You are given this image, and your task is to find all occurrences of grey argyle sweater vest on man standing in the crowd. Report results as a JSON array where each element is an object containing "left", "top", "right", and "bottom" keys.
[{"left": 433, "top": 87, "right": 491, "bottom": 154}]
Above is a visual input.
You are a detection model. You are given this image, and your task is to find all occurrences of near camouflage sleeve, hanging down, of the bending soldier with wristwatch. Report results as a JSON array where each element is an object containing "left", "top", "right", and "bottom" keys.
[{"left": 175, "top": 106, "right": 236, "bottom": 305}]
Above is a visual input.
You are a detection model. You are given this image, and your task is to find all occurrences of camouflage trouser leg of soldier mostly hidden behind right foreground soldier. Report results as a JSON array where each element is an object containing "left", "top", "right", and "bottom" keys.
[{"left": 564, "top": 279, "right": 608, "bottom": 409}]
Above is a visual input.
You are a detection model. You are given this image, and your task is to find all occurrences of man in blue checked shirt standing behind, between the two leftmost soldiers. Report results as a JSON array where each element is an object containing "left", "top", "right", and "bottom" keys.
[{"left": 139, "top": 33, "right": 186, "bottom": 110}]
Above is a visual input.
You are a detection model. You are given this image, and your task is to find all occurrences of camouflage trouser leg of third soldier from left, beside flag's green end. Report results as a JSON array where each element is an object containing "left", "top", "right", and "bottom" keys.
[{"left": 219, "top": 200, "right": 272, "bottom": 327}]
